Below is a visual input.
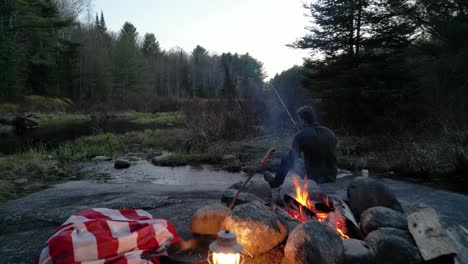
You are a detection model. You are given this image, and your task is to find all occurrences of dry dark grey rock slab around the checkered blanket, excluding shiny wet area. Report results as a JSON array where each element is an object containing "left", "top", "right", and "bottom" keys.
[{"left": 0, "top": 182, "right": 221, "bottom": 263}]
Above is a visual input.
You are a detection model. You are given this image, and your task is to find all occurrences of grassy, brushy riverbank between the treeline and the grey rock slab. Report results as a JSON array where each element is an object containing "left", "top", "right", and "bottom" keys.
[{"left": 0, "top": 108, "right": 468, "bottom": 203}]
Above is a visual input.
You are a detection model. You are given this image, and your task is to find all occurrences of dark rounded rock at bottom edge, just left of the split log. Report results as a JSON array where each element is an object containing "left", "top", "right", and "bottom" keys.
[{"left": 365, "top": 227, "right": 422, "bottom": 264}]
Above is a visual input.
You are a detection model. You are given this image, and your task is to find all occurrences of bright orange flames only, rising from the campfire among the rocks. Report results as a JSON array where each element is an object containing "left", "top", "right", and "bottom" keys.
[{"left": 290, "top": 177, "right": 349, "bottom": 239}]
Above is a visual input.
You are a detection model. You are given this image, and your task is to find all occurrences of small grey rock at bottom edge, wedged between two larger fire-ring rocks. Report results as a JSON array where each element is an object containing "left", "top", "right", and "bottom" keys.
[{"left": 343, "top": 239, "right": 375, "bottom": 264}]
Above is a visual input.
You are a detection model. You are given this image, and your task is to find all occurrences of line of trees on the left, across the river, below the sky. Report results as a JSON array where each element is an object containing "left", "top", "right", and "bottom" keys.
[{"left": 0, "top": 0, "right": 265, "bottom": 101}]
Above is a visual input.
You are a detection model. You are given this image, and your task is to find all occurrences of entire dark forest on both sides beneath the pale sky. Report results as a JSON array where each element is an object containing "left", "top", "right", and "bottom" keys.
[{"left": 0, "top": 0, "right": 468, "bottom": 133}]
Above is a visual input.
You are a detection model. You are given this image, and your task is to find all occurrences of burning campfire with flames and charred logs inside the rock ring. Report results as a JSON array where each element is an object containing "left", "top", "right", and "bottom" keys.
[{"left": 286, "top": 176, "right": 349, "bottom": 239}]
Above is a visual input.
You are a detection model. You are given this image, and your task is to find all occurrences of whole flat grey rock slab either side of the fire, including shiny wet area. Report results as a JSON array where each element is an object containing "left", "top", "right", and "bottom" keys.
[{"left": 0, "top": 173, "right": 468, "bottom": 263}]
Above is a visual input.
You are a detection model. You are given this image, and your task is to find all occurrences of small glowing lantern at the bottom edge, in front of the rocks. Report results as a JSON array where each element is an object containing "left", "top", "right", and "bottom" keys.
[{"left": 208, "top": 230, "right": 244, "bottom": 264}]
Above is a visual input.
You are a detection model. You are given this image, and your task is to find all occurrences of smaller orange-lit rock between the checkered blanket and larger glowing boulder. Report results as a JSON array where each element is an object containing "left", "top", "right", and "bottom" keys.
[{"left": 190, "top": 204, "right": 227, "bottom": 235}]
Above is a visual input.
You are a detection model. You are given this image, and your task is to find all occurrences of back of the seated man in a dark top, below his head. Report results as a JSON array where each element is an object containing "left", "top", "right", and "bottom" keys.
[{"left": 293, "top": 125, "right": 337, "bottom": 183}]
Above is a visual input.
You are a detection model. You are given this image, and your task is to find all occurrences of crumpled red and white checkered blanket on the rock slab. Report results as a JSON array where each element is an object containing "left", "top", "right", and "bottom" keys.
[{"left": 39, "top": 208, "right": 180, "bottom": 264}]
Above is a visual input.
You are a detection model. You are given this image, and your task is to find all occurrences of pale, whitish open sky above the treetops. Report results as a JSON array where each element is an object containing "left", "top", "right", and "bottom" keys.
[{"left": 94, "top": 0, "right": 308, "bottom": 78}]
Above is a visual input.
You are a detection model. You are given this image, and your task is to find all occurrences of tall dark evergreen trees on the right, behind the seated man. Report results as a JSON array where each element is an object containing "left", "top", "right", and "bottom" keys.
[{"left": 272, "top": 0, "right": 468, "bottom": 133}]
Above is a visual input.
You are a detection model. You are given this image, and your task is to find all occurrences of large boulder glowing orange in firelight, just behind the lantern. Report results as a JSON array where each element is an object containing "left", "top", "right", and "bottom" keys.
[{"left": 225, "top": 202, "right": 288, "bottom": 256}]
